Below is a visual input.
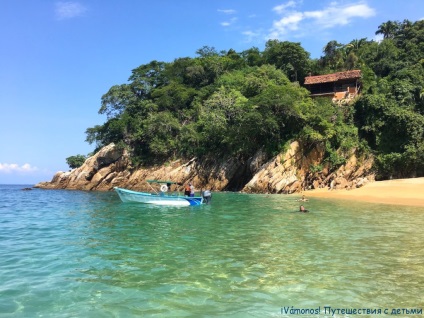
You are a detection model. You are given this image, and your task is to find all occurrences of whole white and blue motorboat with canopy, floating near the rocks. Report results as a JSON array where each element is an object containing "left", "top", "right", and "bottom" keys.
[{"left": 114, "top": 180, "right": 203, "bottom": 206}]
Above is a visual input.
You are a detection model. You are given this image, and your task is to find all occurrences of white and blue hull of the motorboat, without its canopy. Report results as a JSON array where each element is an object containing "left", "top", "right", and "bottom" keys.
[{"left": 114, "top": 187, "right": 203, "bottom": 206}]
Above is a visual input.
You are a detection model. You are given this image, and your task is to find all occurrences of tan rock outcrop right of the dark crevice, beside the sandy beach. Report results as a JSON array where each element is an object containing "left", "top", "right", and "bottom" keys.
[{"left": 243, "top": 141, "right": 374, "bottom": 193}]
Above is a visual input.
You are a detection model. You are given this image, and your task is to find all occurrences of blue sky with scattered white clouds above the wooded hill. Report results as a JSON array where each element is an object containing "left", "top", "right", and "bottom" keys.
[{"left": 0, "top": 0, "right": 424, "bottom": 184}]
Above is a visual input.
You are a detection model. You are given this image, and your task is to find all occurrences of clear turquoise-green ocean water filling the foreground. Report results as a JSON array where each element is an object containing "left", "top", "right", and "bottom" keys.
[{"left": 0, "top": 185, "right": 424, "bottom": 317}]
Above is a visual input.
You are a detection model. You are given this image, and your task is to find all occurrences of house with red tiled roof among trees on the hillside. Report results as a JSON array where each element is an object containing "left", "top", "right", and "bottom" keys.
[{"left": 305, "top": 70, "right": 362, "bottom": 105}]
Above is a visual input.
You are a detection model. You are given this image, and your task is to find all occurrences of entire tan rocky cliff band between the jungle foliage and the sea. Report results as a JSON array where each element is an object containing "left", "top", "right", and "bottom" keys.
[{"left": 36, "top": 142, "right": 374, "bottom": 193}]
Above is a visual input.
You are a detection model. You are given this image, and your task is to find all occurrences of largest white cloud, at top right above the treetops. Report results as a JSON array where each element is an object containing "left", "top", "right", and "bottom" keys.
[{"left": 268, "top": 1, "right": 375, "bottom": 39}]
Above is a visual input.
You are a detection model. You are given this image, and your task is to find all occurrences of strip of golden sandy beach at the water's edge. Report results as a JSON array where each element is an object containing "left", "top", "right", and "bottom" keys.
[{"left": 302, "top": 178, "right": 424, "bottom": 206}]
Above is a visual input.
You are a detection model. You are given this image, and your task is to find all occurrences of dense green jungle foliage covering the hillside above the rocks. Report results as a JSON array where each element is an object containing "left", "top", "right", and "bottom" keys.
[{"left": 86, "top": 20, "right": 424, "bottom": 179}]
